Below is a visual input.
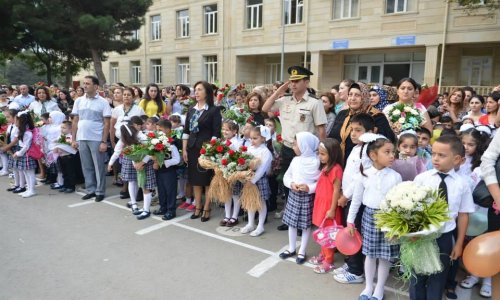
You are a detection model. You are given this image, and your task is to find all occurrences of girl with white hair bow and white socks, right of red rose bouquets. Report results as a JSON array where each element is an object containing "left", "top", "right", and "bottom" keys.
[{"left": 241, "top": 125, "right": 273, "bottom": 236}]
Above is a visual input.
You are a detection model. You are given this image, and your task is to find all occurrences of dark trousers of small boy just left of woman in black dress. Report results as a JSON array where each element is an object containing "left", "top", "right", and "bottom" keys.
[{"left": 156, "top": 167, "right": 177, "bottom": 214}]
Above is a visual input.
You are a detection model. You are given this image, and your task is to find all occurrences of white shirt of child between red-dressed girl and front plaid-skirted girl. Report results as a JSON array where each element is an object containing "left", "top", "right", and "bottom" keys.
[{"left": 342, "top": 145, "right": 372, "bottom": 200}]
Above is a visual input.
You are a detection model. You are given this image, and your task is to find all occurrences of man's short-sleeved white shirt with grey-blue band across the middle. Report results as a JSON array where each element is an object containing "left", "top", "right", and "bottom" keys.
[{"left": 71, "top": 94, "right": 111, "bottom": 141}]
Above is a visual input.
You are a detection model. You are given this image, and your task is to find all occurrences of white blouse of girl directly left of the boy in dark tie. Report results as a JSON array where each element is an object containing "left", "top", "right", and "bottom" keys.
[{"left": 347, "top": 167, "right": 403, "bottom": 223}]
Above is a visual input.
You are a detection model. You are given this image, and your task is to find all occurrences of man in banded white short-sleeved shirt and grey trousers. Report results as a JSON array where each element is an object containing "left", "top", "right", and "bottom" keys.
[{"left": 71, "top": 76, "right": 111, "bottom": 202}]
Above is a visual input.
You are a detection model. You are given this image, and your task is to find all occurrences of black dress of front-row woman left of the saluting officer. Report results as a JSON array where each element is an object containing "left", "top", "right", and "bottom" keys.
[{"left": 184, "top": 106, "right": 222, "bottom": 186}]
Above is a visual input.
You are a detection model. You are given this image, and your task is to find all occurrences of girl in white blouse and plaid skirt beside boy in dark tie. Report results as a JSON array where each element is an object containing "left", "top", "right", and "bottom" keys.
[{"left": 347, "top": 133, "right": 402, "bottom": 300}]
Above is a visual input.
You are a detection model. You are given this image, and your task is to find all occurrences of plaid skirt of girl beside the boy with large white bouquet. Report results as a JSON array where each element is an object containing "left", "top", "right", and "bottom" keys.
[{"left": 361, "top": 207, "right": 399, "bottom": 260}]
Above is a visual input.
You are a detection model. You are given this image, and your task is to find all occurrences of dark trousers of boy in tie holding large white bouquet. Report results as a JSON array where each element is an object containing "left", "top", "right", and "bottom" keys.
[{"left": 410, "top": 232, "right": 453, "bottom": 300}]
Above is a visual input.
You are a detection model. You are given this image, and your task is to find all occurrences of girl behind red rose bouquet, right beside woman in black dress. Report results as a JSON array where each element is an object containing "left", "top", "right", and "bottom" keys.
[{"left": 219, "top": 120, "right": 243, "bottom": 227}]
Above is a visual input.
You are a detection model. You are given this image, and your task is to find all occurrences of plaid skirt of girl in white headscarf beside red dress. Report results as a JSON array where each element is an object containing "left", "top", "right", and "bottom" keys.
[{"left": 283, "top": 190, "right": 314, "bottom": 229}]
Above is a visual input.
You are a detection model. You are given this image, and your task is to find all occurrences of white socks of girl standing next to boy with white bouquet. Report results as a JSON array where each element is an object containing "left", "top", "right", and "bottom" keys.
[{"left": 361, "top": 256, "right": 391, "bottom": 299}]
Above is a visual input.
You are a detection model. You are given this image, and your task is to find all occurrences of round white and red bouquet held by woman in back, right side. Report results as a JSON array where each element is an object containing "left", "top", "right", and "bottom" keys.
[{"left": 387, "top": 103, "right": 425, "bottom": 133}]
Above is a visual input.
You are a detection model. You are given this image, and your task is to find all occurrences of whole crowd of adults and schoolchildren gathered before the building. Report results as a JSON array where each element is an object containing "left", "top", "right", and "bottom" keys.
[{"left": 0, "top": 66, "right": 500, "bottom": 300}]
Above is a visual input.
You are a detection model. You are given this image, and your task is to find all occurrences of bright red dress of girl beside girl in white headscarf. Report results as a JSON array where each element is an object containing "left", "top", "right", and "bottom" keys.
[{"left": 312, "top": 165, "right": 342, "bottom": 227}]
